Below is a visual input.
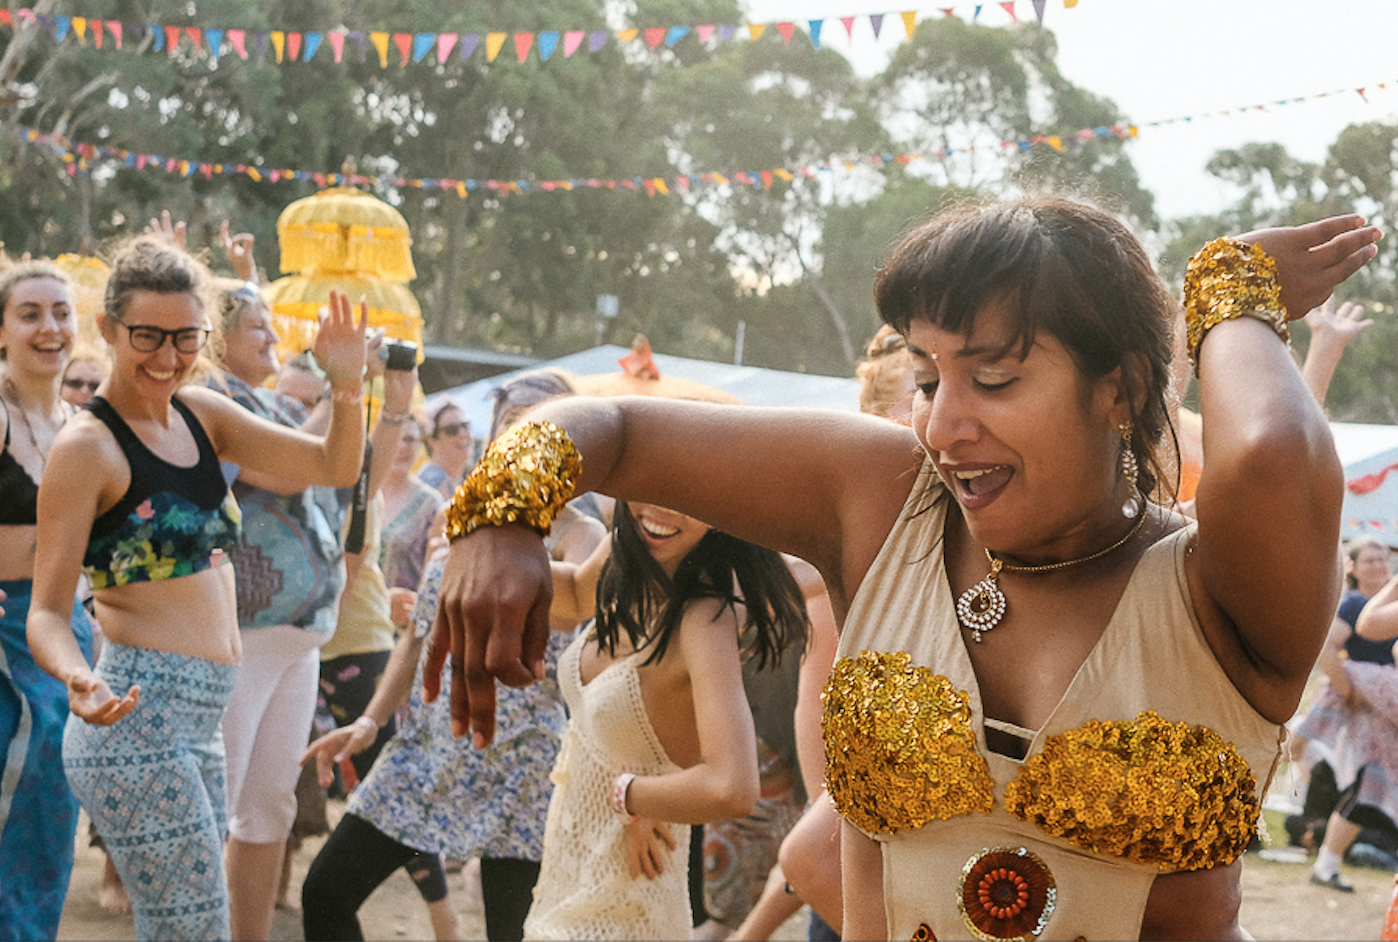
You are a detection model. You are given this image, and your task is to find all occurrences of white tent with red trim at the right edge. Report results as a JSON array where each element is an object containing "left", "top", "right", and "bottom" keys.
[{"left": 1329, "top": 422, "right": 1398, "bottom": 546}]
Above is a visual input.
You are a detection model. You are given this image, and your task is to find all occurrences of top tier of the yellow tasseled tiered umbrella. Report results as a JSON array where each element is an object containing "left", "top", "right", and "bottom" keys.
[{"left": 277, "top": 186, "right": 418, "bottom": 281}]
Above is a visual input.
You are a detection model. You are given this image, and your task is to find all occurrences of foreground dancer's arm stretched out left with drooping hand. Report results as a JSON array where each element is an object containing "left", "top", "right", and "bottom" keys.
[{"left": 424, "top": 397, "right": 923, "bottom": 745}]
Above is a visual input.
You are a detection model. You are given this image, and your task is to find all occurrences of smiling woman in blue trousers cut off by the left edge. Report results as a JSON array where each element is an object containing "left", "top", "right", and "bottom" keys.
[{"left": 0, "top": 261, "right": 92, "bottom": 939}]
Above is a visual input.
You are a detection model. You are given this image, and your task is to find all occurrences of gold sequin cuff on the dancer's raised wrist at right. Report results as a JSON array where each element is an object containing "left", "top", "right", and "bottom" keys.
[{"left": 1184, "top": 239, "right": 1292, "bottom": 376}]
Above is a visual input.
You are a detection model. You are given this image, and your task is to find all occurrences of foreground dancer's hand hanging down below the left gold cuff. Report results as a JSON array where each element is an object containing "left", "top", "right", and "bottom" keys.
[{"left": 422, "top": 524, "right": 554, "bottom": 749}]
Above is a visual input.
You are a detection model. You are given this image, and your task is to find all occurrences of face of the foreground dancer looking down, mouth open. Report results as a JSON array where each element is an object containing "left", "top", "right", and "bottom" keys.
[{"left": 907, "top": 294, "right": 1127, "bottom": 562}]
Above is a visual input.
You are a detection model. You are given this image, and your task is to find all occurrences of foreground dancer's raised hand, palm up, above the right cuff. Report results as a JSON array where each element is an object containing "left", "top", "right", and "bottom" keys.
[{"left": 1237, "top": 215, "right": 1383, "bottom": 320}]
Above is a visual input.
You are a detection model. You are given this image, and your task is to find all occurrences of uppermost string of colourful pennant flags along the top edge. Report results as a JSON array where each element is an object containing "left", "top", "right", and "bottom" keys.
[{"left": 0, "top": 0, "right": 1078, "bottom": 68}]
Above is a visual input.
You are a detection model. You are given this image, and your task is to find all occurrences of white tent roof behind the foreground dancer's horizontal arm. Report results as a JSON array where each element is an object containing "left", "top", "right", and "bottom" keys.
[{"left": 428, "top": 344, "right": 860, "bottom": 440}]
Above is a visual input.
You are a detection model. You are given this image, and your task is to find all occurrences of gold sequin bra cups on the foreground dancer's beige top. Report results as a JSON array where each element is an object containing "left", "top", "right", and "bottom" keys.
[{"left": 822, "top": 651, "right": 1260, "bottom": 872}]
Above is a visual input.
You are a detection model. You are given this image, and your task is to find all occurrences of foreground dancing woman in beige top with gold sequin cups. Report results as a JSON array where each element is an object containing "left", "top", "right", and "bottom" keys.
[{"left": 428, "top": 197, "right": 1380, "bottom": 939}]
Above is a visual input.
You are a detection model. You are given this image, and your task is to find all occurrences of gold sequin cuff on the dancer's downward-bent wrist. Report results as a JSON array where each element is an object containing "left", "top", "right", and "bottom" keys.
[{"left": 446, "top": 422, "right": 583, "bottom": 539}]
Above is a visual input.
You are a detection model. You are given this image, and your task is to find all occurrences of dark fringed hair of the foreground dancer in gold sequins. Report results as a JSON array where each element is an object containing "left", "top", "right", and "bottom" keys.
[{"left": 874, "top": 196, "right": 1179, "bottom": 498}]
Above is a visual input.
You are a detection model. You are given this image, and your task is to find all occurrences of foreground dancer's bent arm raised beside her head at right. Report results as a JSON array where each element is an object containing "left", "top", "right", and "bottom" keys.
[{"left": 1187, "top": 217, "right": 1378, "bottom": 723}]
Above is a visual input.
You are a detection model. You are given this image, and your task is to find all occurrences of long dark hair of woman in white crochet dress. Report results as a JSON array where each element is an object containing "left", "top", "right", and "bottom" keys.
[{"left": 596, "top": 500, "right": 808, "bottom": 669}]
